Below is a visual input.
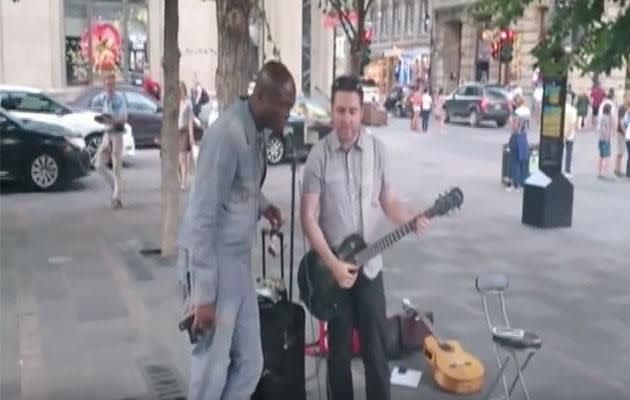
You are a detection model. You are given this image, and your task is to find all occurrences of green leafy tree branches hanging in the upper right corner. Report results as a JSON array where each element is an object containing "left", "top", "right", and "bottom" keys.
[{"left": 473, "top": 0, "right": 630, "bottom": 80}]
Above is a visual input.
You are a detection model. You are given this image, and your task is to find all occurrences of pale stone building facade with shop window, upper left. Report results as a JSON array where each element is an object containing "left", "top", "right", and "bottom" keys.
[{"left": 0, "top": 0, "right": 302, "bottom": 97}]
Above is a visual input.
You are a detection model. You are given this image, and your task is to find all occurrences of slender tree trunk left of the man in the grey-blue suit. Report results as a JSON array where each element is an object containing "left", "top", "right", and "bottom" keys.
[{"left": 161, "top": 0, "right": 180, "bottom": 257}]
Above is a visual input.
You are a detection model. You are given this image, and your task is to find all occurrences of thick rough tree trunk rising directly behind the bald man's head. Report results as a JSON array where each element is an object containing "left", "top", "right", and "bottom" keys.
[{"left": 215, "top": 0, "right": 256, "bottom": 110}]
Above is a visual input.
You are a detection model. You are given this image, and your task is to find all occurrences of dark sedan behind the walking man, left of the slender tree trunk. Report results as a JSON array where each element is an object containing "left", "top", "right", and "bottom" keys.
[{"left": 71, "top": 85, "right": 162, "bottom": 147}]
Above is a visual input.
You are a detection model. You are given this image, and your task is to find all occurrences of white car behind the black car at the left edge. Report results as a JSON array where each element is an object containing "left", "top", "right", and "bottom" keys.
[{"left": 0, "top": 85, "right": 136, "bottom": 165}]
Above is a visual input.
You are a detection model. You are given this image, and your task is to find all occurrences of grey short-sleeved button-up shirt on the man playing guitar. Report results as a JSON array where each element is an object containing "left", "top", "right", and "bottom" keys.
[{"left": 303, "top": 131, "right": 391, "bottom": 278}]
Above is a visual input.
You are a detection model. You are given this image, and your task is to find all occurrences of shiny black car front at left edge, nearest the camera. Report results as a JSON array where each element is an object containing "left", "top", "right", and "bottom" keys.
[{"left": 0, "top": 109, "right": 90, "bottom": 191}]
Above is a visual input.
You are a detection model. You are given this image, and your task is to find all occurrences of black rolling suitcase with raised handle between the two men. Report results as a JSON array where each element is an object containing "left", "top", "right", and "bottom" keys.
[{"left": 252, "top": 229, "right": 306, "bottom": 400}]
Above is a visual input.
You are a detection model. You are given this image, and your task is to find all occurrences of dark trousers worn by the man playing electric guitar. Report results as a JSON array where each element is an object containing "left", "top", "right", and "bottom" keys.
[{"left": 328, "top": 272, "right": 390, "bottom": 400}]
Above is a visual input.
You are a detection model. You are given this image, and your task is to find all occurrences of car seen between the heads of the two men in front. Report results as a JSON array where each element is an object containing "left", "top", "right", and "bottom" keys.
[{"left": 267, "top": 97, "right": 332, "bottom": 165}]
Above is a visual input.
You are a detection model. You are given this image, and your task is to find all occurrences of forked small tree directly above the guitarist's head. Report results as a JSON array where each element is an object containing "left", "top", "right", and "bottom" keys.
[{"left": 319, "top": 0, "right": 374, "bottom": 76}]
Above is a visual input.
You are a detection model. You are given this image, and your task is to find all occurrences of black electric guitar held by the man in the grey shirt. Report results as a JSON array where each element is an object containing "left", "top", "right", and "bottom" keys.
[{"left": 298, "top": 187, "right": 464, "bottom": 321}]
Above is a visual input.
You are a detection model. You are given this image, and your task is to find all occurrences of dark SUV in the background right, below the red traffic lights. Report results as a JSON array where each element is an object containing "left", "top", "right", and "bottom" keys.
[{"left": 444, "top": 83, "right": 510, "bottom": 127}]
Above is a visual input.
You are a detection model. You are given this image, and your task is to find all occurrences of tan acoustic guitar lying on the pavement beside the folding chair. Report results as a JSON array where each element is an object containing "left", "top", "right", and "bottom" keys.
[{"left": 412, "top": 300, "right": 486, "bottom": 394}]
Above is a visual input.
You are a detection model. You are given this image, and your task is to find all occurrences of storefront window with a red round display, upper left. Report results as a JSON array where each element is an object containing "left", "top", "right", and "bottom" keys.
[{"left": 64, "top": 0, "right": 148, "bottom": 85}]
